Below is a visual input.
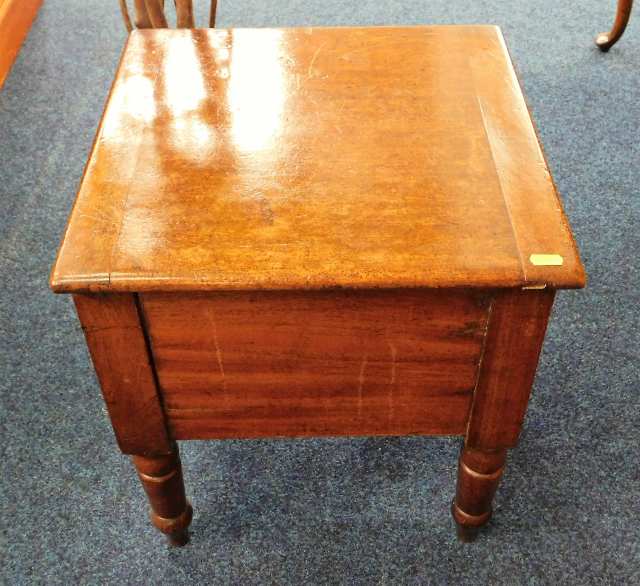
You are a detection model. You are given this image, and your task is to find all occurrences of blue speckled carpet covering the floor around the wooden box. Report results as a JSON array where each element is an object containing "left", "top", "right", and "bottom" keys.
[{"left": 0, "top": 0, "right": 640, "bottom": 585}]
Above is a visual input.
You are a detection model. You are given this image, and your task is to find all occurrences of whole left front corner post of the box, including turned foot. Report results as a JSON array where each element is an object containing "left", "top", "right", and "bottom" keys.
[{"left": 73, "top": 294, "right": 192, "bottom": 545}]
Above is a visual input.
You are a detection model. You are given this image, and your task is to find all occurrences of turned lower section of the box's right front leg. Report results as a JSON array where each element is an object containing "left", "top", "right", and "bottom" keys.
[{"left": 451, "top": 446, "right": 507, "bottom": 542}]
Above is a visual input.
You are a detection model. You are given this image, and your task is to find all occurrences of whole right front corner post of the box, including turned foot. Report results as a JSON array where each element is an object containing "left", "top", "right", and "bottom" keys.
[{"left": 452, "top": 289, "right": 555, "bottom": 541}]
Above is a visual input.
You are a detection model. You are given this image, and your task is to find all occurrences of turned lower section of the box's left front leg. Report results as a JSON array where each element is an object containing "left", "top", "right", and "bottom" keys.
[{"left": 132, "top": 446, "right": 193, "bottom": 546}]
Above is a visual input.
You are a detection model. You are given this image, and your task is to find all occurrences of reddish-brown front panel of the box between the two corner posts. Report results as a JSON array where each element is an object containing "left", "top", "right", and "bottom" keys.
[{"left": 141, "top": 290, "right": 490, "bottom": 439}]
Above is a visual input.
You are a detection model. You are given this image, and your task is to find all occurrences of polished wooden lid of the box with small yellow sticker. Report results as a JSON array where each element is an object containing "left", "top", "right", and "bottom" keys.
[{"left": 51, "top": 26, "right": 584, "bottom": 291}]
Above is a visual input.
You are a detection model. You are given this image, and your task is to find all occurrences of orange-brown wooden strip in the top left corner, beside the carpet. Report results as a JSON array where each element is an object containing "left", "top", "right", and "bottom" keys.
[{"left": 0, "top": 0, "right": 42, "bottom": 88}]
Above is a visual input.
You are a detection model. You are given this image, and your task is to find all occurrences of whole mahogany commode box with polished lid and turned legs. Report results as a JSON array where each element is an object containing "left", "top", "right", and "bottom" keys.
[{"left": 51, "top": 26, "right": 585, "bottom": 544}]
